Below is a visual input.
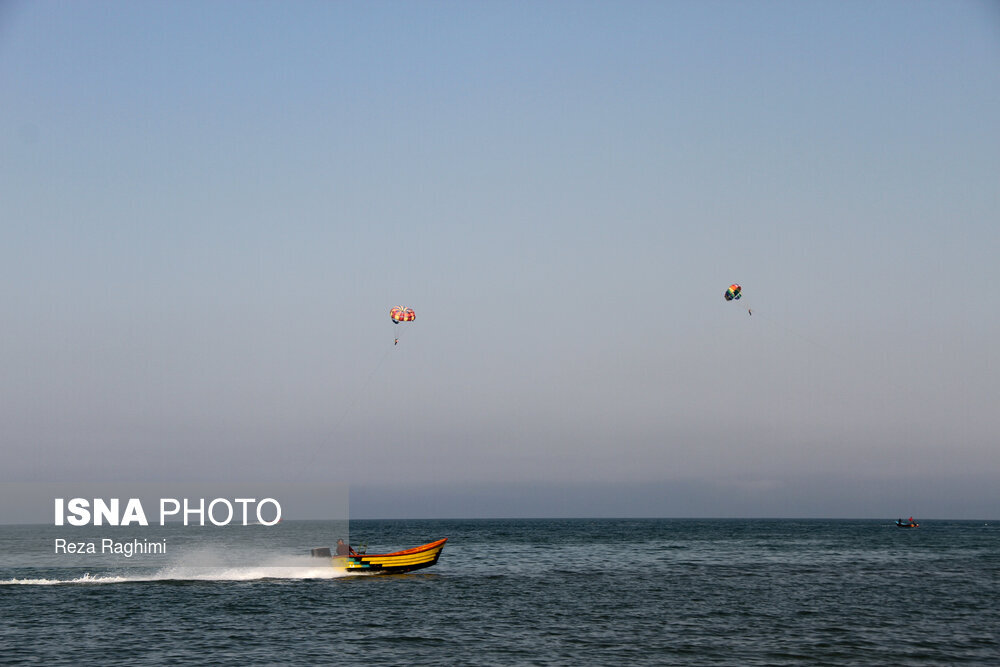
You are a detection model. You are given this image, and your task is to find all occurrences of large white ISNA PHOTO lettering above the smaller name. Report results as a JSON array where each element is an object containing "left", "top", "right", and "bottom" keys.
[{"left": 55, "top": 498, "right": 281, "bottom": 526}]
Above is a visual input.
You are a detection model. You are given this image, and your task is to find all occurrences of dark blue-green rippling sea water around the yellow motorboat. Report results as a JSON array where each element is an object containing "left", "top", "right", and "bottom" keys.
[{"left": 0, "top": 519, "right": 1000, "bottom": 665}]
